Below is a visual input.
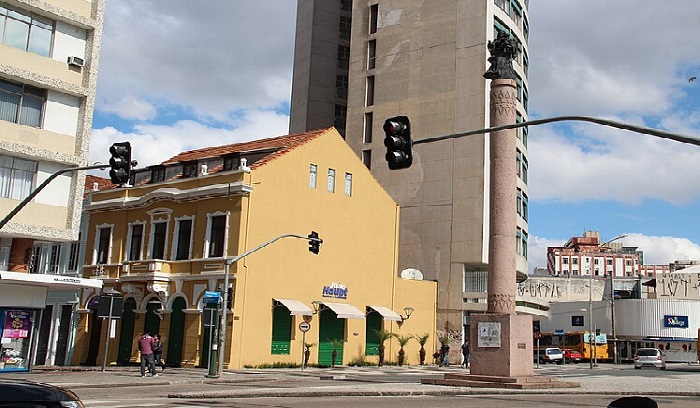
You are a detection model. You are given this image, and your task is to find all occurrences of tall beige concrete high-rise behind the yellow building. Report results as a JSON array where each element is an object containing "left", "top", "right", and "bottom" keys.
[{"left": 290, "top": 0, "right": 529, "bottom": 338}]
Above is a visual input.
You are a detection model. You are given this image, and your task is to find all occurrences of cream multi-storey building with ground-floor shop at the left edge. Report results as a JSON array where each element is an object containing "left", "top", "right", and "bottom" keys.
[{"left": 0, "top": 0, "right": 107, "bottom": 371}]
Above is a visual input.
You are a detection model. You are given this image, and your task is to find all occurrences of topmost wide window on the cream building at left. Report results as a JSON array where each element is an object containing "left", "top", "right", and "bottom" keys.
[{"left": 0, "top": 5, "right": 53, "bottom": 57}]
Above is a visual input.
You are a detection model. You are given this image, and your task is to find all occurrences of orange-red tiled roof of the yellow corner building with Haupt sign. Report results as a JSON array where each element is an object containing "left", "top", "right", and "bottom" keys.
[{"left": 161, "top": 128, "right": 332, "bottom": 169}]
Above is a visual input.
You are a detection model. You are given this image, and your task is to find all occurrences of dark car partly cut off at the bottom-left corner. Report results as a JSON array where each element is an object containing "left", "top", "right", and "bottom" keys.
[{"left": 0, "top": 379, "right": 85, "bottom": 408}]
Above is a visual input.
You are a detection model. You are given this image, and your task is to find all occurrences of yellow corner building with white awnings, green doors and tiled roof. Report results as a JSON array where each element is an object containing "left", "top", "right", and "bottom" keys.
[{"left": 73, "top": 128, "right": 436, "bottom": 368}]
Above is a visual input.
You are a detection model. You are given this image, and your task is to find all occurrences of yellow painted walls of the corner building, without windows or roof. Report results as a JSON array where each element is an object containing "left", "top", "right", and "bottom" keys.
[{"left": 77, "top": 130, "right": 436, "bottom": 368}]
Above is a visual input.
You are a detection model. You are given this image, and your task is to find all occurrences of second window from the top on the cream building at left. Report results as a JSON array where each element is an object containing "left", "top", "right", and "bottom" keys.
[{"left": 0, "top": 79, "right": 46, "bottom": 127}]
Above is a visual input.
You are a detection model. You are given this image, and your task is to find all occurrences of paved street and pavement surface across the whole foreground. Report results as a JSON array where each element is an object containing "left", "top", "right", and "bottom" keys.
[{"left": 9, "top": 364, "right": 700, "bottom": 408}]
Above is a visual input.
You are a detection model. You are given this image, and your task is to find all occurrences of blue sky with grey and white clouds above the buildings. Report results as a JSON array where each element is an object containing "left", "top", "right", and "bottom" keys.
[{"left": 91, "top": 0, "right": 700, "bottom": 270}]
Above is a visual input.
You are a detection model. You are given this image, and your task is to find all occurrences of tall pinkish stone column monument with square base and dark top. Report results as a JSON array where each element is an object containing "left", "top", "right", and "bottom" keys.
[{"left": 469, "top": 33, "right": 533, "bottom": 378}]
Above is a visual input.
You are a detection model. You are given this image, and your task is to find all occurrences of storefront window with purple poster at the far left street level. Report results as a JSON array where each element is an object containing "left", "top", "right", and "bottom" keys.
[{"left": 0, "top": 309, "right": 35, "bottom": 371}]
